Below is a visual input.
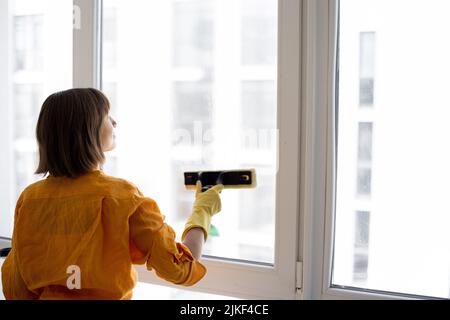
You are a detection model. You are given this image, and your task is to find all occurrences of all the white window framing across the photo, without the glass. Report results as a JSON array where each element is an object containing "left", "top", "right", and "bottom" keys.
[{"left": 0, "top": 0, "right": 440, "bottom": 299}]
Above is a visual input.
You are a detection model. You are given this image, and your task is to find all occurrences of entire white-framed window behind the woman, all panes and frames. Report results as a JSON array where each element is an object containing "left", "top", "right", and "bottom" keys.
[{"left": 0, "top": 0, "right": 450, "bottom": 298}]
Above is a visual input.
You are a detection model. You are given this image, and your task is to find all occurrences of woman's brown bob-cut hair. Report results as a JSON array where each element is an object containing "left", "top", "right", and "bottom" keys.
[{"left": 36, "top": 88, "right": 110, "bottom": 178}]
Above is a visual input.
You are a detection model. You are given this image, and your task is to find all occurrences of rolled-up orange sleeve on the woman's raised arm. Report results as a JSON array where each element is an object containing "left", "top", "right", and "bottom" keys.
[{"left": 129, "top": 198, "right": 206, "bottom": 286}]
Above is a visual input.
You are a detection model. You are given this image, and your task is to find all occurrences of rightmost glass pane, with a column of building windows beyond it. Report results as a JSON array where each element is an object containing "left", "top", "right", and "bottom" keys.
[{"left": 333, "top": 0, "right": 450, "bottom": 298}]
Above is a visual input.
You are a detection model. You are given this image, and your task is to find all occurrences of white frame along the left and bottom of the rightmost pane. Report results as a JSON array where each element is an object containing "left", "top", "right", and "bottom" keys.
[{"left": 299, "top": 0, "right": 425, "bottom": 300}]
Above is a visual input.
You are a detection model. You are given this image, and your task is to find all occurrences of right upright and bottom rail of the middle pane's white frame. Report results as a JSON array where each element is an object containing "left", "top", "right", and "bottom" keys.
[{"left": 137, "top": 0, "right": 301, "bottom": 299}]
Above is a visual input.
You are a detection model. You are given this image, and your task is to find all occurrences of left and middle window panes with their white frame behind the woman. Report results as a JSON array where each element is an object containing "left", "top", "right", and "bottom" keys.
[{"left": 0, "top": 0, "right": 300, "bottom": 298}]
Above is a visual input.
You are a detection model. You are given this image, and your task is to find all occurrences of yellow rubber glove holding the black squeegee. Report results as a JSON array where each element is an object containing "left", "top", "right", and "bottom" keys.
[{"left": 181, "top": 181, "right": 223, "bottom": 241}]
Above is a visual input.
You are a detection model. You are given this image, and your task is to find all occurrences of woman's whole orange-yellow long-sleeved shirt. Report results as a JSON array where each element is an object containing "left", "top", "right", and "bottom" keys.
[{"left": 2, "top": 170, "right": 206, "bottom": 299}]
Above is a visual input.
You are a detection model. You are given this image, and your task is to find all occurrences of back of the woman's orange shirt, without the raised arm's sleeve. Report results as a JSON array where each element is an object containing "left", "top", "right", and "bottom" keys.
[{"left": 5, "top": 170, "right": 148, "bottom": 299}]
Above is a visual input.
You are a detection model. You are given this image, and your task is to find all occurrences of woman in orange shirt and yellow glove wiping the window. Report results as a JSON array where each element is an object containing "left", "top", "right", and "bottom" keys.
[{"left": 2, "top": 88, "right": 223, "bottom": 299}]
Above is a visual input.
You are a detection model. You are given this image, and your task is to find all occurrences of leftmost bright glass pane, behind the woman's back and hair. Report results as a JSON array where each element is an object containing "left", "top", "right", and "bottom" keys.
[{"left": 0, "top": 0, "right": 74, "bottom": 237}]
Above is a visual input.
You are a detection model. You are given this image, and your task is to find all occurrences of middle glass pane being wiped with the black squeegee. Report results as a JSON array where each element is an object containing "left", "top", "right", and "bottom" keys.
[{"left": 103, "top": 0, "right": 278, "bottom": 264}]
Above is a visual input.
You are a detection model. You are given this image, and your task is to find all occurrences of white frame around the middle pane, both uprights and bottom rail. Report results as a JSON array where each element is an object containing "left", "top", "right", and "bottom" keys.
[{"left": 74, "top": 0, "right": 301, "bottom": 299}]
